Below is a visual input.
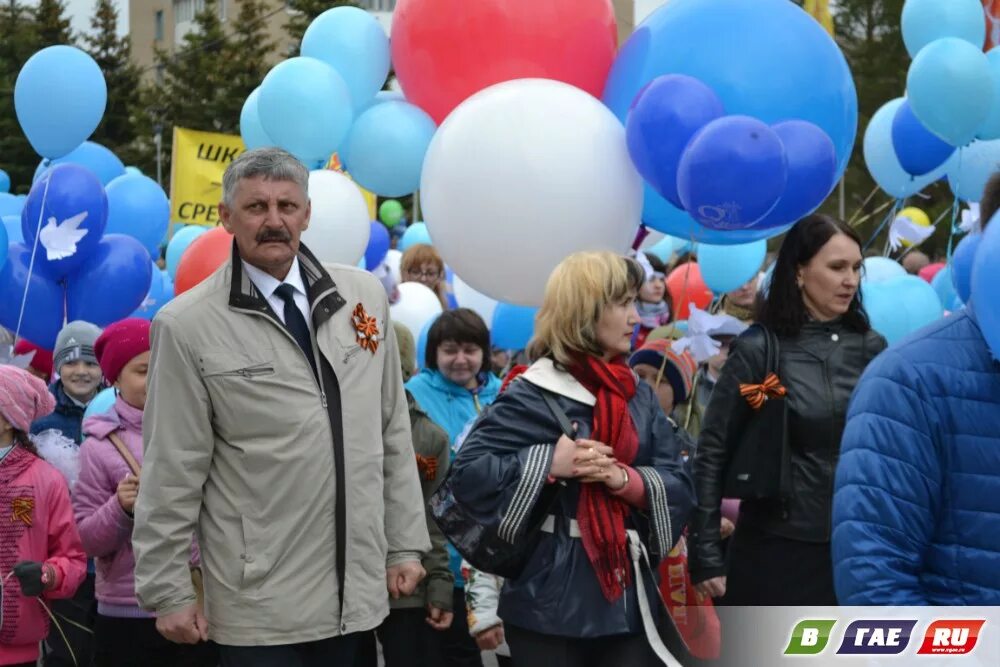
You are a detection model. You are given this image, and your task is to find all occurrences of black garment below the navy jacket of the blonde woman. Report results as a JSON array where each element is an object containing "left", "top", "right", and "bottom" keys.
[{"left": 504, "top": 625, "right": 661, "bottom": 667}]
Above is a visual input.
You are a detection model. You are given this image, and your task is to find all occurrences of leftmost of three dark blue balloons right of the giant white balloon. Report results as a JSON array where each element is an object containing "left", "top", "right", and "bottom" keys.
[{"left": 625, "top": 74, "right": 725, "bottom": 208}]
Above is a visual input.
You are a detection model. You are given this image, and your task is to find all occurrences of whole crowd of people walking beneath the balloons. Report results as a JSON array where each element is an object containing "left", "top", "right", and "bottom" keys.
[{"left": 0, "top": 149, "right": 1000, "bottom": 667}]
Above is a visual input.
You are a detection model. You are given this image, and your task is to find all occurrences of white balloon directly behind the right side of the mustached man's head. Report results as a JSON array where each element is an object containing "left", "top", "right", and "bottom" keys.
[{"left": 302, "top": 169, "right": 371, "bottom": 266}]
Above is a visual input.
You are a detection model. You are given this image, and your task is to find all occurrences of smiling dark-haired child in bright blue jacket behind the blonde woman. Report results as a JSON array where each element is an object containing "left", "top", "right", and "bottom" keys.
[{"left": 406, "top": 308, "right": 501, "bottom": 667}]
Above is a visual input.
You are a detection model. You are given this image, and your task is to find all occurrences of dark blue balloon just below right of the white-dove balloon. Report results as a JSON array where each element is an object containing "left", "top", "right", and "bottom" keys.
[{"left": 66, "top": 234, "right": 153, "bottom": 327}]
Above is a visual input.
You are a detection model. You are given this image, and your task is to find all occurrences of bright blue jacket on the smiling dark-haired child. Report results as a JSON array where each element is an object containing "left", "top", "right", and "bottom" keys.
[{"left": 406, "top": 368, "right": 502, "bottom": 446}]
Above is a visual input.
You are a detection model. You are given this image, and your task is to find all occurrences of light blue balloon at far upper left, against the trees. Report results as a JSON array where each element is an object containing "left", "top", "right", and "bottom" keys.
[{"left": 14, "top": 45, "right": 108, "bottom": 160}]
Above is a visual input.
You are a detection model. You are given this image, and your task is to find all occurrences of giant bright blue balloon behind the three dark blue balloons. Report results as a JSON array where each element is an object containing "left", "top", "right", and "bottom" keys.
[{"left": 603, "top": 0, "right": 858, "bottom": 190}]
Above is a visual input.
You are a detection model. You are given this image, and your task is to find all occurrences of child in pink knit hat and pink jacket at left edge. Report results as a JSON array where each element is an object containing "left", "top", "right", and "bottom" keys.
[{"left": 0, "top": 366, "right": 87, "bottom": 667}]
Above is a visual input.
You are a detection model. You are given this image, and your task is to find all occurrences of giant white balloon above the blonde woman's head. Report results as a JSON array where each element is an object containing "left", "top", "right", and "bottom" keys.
[{"left": 420, "top": 79, "right": 642, "bottom": 306}]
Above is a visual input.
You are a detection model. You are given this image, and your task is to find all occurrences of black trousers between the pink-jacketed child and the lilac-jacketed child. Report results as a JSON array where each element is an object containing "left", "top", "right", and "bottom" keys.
[{"left": 42, "top": 574, "right": 97, "bottom": 667}]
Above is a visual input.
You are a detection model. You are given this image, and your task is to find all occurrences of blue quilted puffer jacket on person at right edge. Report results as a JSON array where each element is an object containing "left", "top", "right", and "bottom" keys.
[{"left": 832, "top": 308, "right": 1000, "bottom": 606}]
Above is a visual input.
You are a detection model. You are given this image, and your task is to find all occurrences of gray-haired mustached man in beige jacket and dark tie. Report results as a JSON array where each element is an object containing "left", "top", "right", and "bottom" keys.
[{"left": 133, "top": 148, "right": 430, "bottom": 667}]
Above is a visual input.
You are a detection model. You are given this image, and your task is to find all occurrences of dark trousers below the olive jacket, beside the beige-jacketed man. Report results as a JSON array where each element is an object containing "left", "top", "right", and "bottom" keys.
[{"left": 354, "top": 607, "right": 445, "bottom": 667}]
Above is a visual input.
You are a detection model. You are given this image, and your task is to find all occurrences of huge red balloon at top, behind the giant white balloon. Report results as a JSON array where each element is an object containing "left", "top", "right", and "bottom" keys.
[{"left": 392, "top": 0, "right": 618, "bottom": 125}]
